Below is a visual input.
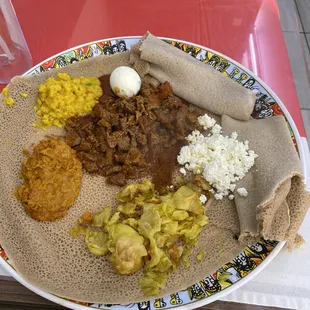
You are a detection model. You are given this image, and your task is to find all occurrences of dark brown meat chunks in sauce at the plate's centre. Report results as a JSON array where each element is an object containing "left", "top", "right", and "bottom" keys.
[{"left": 65, "top": 76, "right": 204, "bottom": 189}]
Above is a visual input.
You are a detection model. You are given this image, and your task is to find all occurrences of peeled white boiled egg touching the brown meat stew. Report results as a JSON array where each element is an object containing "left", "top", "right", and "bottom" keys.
[{"left": 110, "top": 66, "right": 141, "bottom": 98}]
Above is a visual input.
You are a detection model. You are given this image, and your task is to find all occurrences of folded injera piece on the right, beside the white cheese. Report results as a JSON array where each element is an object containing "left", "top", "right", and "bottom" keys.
[{"left": 222, "top": 115, "right": 310, "bottom": 247}]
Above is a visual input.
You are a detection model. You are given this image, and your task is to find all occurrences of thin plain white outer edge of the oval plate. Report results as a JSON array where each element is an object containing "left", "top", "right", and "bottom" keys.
[{"left": 0, "top": 36, "right": 306, "bottom": 310}]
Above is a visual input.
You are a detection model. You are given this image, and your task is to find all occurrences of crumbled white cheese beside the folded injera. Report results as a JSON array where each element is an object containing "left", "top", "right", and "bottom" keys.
[{"left": 177, "top": 114, "right": 257, "bottom": 199}]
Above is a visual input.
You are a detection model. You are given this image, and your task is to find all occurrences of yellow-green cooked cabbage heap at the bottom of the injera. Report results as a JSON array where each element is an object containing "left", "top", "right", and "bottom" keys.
[{"left": 70, "top": 179, "right": 208, "bottom": 296}]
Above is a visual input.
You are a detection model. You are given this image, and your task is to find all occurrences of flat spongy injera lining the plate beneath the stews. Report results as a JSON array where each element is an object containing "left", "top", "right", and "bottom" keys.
[{"left": 0, "top": 53, "right": 242, "bottom": 304}]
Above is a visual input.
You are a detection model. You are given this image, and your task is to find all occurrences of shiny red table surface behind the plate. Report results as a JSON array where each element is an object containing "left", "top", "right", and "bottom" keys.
[{"left": 5, "top": 0, "right": 305, "bottom": 136}]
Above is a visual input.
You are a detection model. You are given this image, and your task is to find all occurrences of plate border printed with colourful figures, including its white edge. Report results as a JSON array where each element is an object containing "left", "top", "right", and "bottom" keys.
[{"left": 0, "top": 37, "right": 303, "bottom": 310}]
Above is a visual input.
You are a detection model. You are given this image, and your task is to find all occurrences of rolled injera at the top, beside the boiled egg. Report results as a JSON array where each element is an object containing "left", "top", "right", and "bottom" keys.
[{"left": 130, "top": 33, "right": 255, "bottom": 120}]
